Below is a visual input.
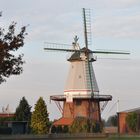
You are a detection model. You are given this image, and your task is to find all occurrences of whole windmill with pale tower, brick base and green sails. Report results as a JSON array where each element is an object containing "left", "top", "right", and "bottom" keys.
[{"left": 44, "top": 8, "right": 129, "bottom": 131}]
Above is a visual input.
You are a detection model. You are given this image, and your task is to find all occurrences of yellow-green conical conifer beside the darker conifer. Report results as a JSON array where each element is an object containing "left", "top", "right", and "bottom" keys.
[{"left": 31, "top": 97, "right": 49, "bottom": 134}]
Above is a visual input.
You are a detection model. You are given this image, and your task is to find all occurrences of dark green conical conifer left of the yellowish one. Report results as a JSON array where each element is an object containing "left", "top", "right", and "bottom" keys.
[{"left": 15, "top": 97, "right": 31, "bottom": 123}]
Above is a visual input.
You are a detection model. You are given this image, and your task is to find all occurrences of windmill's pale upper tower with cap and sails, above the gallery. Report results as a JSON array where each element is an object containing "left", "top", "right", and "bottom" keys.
[{"left": 44, "top": 8, "right": 129, "bottom": 99}]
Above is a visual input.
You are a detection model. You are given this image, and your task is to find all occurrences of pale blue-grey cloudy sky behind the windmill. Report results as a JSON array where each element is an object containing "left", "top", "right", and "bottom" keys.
[{"left": 0, "top": 0, "right": 140, "bottom": 120}]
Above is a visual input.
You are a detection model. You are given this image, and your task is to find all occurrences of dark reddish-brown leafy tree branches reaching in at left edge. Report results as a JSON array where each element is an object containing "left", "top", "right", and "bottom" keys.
[{"left": 0, "top": 18, "right": 27, "bottom": 84}]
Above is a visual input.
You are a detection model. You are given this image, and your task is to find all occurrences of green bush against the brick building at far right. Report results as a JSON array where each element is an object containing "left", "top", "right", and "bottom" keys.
[{"left": 126, "top": 112, "right": 138, "bottom": 132}]
